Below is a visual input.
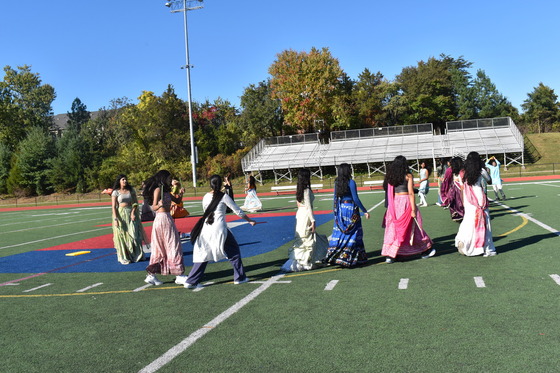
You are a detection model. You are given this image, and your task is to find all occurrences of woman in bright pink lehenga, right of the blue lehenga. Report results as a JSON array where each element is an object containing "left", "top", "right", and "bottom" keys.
[{"left": 381, "top": 155, "right": 435, "bottom": 263}]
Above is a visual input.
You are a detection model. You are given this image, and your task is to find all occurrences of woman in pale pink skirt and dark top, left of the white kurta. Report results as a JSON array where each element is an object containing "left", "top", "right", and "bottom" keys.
[{"left": 144, "top": 170, "right": 187, "bottom": 285}]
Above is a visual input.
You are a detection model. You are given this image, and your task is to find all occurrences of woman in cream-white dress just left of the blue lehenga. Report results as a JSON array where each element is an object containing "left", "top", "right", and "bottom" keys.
[{"left": 282, "top": 168, "right": 329, "bottom": 272}]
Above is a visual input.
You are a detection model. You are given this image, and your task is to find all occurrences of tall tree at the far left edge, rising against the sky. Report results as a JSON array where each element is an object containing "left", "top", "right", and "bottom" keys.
[{"left": 0, "top": 65, "right": 56, "bottom": 150}]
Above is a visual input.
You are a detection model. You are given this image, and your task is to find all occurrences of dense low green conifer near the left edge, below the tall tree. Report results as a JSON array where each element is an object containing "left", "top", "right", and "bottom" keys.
[{"left": 8, "top": 127, "right": 55, "bottom": 195}]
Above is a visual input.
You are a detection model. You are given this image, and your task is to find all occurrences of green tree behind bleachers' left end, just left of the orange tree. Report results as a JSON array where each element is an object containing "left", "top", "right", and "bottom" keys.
[{"left": 239, "top": 80, "right": 284, "bottom": 146}]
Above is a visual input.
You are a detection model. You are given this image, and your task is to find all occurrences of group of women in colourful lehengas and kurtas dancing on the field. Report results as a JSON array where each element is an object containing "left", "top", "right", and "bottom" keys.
[{"left": 108, "top": 152, "right": 498, "bottom": 289}]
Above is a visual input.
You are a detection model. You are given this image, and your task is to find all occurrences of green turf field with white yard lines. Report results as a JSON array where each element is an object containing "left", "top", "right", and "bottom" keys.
[{"left": 0, "top": 180, "right": 560, "bottom": 372}]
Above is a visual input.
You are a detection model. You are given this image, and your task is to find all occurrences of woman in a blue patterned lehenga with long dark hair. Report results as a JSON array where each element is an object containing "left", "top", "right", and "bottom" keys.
[{"left": 326, "top": 163, "right": 369, "bottom": 267}]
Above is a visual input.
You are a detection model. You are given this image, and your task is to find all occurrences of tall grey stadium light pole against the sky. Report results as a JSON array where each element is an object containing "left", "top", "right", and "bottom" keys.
[{"left": 165, "top": 0, "right": 204, "bottom": 188}]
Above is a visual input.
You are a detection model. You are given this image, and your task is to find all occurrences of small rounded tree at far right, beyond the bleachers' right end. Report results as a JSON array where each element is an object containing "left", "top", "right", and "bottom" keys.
[{"left": 521, "top": 82, "right": 560, "bottom": 133}]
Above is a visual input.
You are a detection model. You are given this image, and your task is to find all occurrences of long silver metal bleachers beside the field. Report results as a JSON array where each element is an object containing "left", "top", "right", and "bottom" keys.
[{"left": 242, "top": 117, "right": 524, "bottom": 183}]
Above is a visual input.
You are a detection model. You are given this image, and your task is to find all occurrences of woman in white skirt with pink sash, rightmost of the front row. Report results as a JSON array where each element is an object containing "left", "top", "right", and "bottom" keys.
[{"left": 455, "top": 152, "right": 496, "bottom": 257}]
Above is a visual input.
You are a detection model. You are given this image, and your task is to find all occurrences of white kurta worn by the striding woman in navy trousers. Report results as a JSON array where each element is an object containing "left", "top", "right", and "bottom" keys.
[{"left": 193, "top": 193, "right": 245, "bottom": 263}]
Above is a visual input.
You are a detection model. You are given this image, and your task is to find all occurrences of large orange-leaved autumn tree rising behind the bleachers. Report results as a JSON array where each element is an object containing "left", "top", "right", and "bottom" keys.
[{"left": 268, "top": 48, "right": 344, "bottom": 132}]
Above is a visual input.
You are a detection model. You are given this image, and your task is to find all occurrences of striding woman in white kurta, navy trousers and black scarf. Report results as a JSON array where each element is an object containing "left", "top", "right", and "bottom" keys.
[{"left": 185, "top": 175, "right": 256, "bottom": 289}]
